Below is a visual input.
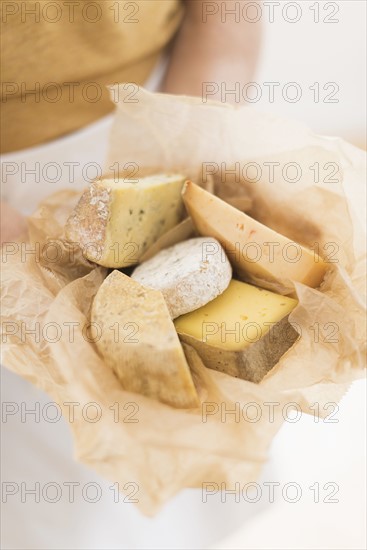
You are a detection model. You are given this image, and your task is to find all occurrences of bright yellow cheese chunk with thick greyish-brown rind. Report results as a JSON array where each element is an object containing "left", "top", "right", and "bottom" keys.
[{"left": 174, "top": 280, "right": 298, "bottom": 382}]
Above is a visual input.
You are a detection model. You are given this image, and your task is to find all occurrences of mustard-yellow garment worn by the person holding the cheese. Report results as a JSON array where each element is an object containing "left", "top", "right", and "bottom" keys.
[{"left": 1, "top": 0, "right": 182, "bottom": 153}]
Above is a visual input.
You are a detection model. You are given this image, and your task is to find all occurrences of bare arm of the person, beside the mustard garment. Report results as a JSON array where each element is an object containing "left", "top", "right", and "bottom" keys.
[{"left": 161, "top": 0, "right": 261, "bottom": 103}]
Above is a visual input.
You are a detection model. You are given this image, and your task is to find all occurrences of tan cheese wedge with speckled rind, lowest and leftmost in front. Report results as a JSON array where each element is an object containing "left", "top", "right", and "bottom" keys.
[{"left": 91, "top": 270, "right": 199, "bottom": 408}]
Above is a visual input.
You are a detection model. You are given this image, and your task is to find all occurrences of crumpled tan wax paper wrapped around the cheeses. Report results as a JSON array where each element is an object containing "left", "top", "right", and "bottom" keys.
[{"left": 2, "top": 85, "right": 365, "bottom": 514}]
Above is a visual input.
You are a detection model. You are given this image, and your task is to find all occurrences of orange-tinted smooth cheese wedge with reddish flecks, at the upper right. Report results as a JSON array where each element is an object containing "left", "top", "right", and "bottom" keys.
[{"left": 182, "top": 182, "right": 328, "bottom": 294}]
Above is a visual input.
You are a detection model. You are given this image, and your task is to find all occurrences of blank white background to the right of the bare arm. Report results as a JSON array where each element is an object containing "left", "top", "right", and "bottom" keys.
[{"left": 254, "top": 0, "right": 367, "bottom": 146}]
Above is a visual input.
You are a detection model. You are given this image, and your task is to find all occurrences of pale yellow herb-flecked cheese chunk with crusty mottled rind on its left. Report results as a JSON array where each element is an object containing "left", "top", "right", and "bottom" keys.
[{"left": 65, "top": 174, "right": 184, "bottom": 268}]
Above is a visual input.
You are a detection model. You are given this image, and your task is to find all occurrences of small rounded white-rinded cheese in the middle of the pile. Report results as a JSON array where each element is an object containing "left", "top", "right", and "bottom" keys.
[{"left": 131, "top": 237, "right": 232, "bottom": 319}]
